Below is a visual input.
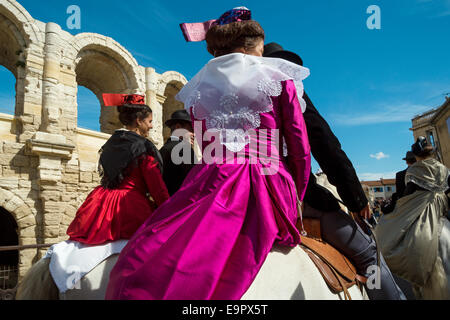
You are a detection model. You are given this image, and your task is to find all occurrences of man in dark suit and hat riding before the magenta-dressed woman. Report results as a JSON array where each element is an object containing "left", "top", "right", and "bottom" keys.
[{"left": 263, "top": 43, "right": 405, "bottom": 300}]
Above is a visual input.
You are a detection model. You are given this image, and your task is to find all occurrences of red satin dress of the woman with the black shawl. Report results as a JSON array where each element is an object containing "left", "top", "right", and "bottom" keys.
[{"left": 67, "top": 155, "right": 169, "bottom": 245}]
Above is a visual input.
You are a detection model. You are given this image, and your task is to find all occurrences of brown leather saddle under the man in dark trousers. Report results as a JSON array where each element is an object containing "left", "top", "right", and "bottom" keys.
[{"left": 297, "top": 217, "right": 367, "bottom": 300}]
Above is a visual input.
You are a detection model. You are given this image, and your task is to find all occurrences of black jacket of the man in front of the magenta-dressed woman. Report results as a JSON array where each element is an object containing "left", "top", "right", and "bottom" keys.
[{"left": 303, "top": 93, "right": 368, "bottom": 212}]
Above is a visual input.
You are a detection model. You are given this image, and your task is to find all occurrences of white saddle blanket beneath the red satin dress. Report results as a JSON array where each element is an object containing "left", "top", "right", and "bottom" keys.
[{"left": 43, "top": 240, "right": 128, "bottom": 293}]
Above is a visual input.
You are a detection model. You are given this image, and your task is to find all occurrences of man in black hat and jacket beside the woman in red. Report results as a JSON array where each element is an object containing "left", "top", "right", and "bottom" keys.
[{"left": 159, "top": 109, "right": 195, "bottom": 195}]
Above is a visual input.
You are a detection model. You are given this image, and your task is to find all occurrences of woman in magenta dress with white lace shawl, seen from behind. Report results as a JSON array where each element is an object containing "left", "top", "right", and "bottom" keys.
[{"left": 106, "top": 7, "right": 311, "bottom": 300}]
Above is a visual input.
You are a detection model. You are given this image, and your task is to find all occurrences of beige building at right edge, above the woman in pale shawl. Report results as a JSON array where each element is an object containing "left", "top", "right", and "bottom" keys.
[{"left": 410, "top": 97, "right": 450, "bottom": 168}]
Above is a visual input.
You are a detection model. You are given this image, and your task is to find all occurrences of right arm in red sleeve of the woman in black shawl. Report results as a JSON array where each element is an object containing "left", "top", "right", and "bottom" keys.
[{"left": 140, "top": 156, "right": 169, "bottom": 206}]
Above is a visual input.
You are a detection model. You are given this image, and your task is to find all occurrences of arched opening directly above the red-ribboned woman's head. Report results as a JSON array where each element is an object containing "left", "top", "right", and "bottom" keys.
[{"left": 75, "top": 45, "right": 133, "bottom": 134}]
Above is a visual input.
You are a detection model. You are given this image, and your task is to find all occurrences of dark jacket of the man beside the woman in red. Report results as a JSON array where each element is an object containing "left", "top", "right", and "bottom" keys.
[{"left": 159, "top": 138, "right": 195, "bottom": 195}]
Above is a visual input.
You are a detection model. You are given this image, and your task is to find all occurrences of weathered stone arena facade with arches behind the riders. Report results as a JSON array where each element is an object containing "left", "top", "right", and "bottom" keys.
[{"left": 0, "top": 0, "right": 187, "bottom": 276}]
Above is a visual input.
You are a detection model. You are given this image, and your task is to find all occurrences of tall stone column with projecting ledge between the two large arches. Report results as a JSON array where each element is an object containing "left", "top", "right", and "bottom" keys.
[{"left": 27, "top": 22, "right": 75, "bottom": 253}]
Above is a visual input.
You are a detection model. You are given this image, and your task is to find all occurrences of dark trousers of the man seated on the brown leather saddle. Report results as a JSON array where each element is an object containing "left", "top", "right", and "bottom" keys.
[{"left": 303, "top": 203, "right": 406, "bottom": 300}]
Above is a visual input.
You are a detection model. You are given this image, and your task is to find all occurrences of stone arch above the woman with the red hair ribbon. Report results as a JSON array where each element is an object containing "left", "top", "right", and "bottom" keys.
[{"left": 66, "top": 33, "right": 145, "bottom": 134}]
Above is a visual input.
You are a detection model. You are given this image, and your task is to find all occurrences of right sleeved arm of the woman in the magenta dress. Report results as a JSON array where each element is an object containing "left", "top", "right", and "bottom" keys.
[{"left": 280, "top": 80, "right": 311, "bottom": 201}]
